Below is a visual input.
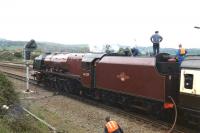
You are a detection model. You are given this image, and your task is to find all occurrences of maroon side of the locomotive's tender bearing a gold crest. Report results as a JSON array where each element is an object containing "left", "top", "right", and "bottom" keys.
[{"left": 96, "top": 57, "right": 165, "bottom": 101}]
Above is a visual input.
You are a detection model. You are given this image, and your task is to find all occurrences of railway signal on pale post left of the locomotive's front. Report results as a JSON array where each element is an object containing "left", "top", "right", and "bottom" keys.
[{"left": 24, "top": 39, "right": 37, "bottom": 92}]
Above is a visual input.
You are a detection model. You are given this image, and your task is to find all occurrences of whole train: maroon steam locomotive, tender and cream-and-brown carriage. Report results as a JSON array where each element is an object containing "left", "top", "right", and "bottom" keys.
[{"left": 33, "top": 53, "right": 200, "bottom": 125}]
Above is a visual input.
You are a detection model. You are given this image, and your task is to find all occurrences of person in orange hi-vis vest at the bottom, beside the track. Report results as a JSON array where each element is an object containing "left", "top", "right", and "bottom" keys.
[{"left": 104, "top": 116, "right": 123, "bottom": 133}]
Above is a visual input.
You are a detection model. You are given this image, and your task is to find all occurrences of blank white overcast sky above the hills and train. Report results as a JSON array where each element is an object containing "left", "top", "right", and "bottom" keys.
[{"left": 0, "top": 0, "right": 200, "bottom": 48}]
